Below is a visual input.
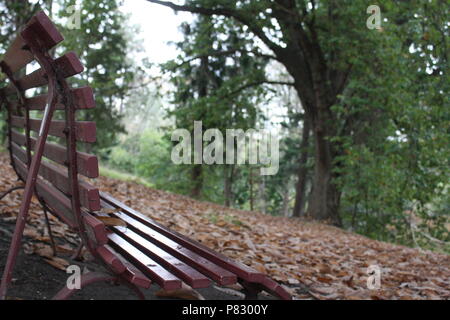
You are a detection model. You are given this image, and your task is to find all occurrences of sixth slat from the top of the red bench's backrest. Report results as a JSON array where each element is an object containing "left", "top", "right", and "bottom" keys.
[{"left": 11, "top": 142, "right": 100, "bottom": 211}]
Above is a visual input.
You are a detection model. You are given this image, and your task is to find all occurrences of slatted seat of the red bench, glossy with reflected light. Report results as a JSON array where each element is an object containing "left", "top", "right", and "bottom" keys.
[{"left": 93, "top": 192, "right": 290, "bottom": 299}]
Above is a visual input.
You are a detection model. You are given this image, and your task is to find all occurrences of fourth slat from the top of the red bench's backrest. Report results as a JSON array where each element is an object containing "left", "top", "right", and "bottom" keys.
[{"left": 11, "top": 116, "right": 97, "bottom": 143}]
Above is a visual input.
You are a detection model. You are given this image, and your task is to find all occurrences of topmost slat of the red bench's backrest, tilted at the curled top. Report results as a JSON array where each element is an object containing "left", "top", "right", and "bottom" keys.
[{"left": 3, "top": 12, "right": 64, "bottom": 73}]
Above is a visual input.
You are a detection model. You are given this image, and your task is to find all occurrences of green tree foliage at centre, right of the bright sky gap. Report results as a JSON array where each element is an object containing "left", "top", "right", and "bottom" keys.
[{"left": 164, "top": 17, "right": 267, "bottom": 202}]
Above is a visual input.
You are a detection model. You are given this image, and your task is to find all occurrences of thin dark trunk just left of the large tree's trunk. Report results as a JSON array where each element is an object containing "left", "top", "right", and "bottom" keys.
[{"left": 292, "top": 117, "right": 311, "bottom": 217}]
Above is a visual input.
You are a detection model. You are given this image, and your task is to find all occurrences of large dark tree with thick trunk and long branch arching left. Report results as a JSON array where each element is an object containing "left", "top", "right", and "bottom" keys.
[{"left": 148, "top": 0, "right": 448, "bottom": 225}]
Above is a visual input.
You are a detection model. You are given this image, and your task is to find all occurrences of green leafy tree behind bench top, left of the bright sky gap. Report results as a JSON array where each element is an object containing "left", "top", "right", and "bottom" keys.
[{"left": 58, "top": 0, "right": 136, "bottom": 150}]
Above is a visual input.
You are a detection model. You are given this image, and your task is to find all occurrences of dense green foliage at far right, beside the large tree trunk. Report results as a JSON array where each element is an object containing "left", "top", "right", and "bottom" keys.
[{"left": 334, "top": 2, "right": 450, "bottom": 248}]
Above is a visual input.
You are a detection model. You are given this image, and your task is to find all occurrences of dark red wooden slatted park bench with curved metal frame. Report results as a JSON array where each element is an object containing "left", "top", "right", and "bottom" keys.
[{"left": 0, "top": 12, "right": 291, "bottom": 300}]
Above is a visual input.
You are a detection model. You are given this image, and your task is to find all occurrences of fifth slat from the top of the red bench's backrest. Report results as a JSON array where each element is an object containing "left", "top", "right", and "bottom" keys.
[{"left": 11, "top": 129, "right": 99, "bottom": 178}]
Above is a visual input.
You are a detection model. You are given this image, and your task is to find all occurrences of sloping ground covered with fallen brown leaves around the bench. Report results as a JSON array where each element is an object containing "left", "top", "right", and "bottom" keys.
[{"left": 0, "top": 153, "right": 450, "bottom": 300}]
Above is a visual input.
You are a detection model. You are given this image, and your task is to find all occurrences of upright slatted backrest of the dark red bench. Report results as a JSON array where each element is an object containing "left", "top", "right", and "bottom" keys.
[{"left": 0, "top": 12, "right": 104, "bottom": 240}]
